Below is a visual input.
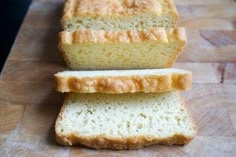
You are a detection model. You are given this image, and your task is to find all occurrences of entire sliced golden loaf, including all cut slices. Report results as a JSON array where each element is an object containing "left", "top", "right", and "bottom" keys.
[{"left": 55, "top": 0, "right": 196, "bottom": 149}]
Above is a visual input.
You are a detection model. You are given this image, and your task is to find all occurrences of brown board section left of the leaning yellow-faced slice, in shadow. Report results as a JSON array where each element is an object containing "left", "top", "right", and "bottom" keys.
[{"left": 9, "top": 26, "right": 62, "bottom": 61}]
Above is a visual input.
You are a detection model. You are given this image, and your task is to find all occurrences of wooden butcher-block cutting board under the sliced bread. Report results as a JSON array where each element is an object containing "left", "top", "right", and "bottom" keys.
[{"left": 0, "top": 0, "right": 236, "bottom": 157}]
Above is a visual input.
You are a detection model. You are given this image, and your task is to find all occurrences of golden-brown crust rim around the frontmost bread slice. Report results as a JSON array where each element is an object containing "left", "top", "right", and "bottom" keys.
[{"left": 55, "top": 92, "right": 197, "bottom": 150}]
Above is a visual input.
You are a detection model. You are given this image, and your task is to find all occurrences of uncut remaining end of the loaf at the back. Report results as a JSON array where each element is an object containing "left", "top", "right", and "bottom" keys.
[{"left": 61, "top": 0, "right": 178, "bottom": 31}]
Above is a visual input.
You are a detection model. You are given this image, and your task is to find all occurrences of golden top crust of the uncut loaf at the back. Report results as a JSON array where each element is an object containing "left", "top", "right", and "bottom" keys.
[{"left": 62, "top": 0, "right": 178, "bottom": 19}]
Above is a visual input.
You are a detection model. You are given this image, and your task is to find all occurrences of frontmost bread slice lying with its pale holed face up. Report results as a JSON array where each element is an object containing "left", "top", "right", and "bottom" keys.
[{"left": 55, "top": 92, "right": 196, "bottom": 149}]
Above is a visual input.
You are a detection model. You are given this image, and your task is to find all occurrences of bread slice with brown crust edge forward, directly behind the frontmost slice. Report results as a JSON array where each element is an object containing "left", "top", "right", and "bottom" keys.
[{"left": 54, "top": 68, "right": 192, "bottom": 93}]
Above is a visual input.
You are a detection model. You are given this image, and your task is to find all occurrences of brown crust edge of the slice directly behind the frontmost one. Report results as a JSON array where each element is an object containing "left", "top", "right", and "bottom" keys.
[{"left": 54, "top": 73, "right": 192, "bottom": 93}]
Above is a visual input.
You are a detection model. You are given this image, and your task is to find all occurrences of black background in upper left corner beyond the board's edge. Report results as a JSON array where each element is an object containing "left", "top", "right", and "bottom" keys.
[{"left": 0, "top": 0, "right": 31, "bottom": 72}]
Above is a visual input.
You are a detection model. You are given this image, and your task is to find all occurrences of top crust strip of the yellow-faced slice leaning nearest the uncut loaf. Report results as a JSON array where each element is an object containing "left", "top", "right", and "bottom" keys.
[{"left": 59, "top": 27, "right": 187, "bottom": 46}]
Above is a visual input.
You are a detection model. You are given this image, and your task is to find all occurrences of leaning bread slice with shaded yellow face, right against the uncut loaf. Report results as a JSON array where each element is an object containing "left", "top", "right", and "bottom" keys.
[{"left": 59, "top": 28, "right": 186, "bottom": 70}]
